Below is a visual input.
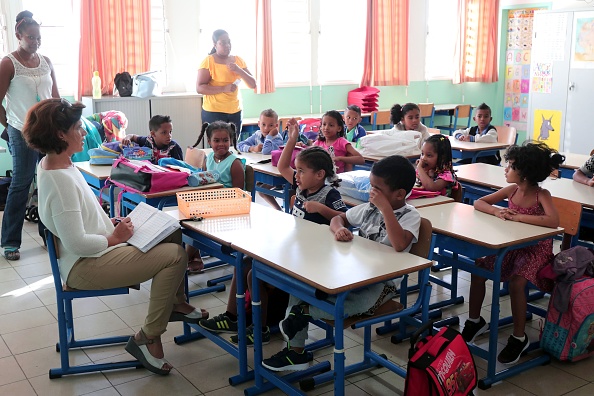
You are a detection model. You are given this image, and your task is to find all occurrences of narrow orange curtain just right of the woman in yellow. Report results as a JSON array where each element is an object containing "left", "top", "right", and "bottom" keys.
[{"left": 254, "top": 0, "right": 275, "bottom": 94}]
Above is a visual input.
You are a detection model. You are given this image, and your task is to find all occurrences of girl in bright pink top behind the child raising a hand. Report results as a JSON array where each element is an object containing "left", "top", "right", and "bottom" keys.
[{"left": 314, "top": 110, "right": 365, "bottom": 173}]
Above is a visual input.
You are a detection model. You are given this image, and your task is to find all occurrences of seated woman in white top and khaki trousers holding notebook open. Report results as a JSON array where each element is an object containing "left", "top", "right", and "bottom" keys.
[{"left": 23, "top": 99, "right": 208, "bottom": 375}]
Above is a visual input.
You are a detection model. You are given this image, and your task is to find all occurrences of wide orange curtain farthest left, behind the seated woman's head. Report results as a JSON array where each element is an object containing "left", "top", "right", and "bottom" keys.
[{"left": 78, "top": 0, "right": 151, "bottom": 98}]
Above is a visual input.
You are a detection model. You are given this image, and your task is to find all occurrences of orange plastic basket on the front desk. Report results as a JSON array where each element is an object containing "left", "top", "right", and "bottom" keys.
[{"left": 177, "top": 188, "right": 252, "bottom": 218}]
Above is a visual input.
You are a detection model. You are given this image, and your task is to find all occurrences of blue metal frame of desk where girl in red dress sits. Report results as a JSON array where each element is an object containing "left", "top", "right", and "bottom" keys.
[{"left": 433, "top": 233, "right": 550, "bottom": 389}]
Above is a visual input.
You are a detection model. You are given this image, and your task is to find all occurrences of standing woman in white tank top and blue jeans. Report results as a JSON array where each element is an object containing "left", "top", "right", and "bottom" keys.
[{"left": 0, "top": 11, "right": 60, "bottom": 260}]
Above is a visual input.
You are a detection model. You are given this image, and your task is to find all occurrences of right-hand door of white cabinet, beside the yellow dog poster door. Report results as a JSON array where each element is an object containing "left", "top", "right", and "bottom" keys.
[{"left": 563, "top": 11, "right": 594, "bottom": 154}]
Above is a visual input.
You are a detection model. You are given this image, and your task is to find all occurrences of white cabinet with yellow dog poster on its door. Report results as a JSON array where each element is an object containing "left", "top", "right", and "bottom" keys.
[{"left": 528, "top": 11, "right": 594, "bottom": 154}]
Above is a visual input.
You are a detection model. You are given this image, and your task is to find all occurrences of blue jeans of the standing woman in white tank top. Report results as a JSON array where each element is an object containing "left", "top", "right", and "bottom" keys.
[{"left": 2, "top": 125, "right": 39, "bottom": 249}]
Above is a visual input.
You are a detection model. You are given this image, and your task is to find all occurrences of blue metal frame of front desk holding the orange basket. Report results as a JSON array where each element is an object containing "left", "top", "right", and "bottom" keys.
[{"left": 245, "top": 260, "right": 431, "bottom": 396}]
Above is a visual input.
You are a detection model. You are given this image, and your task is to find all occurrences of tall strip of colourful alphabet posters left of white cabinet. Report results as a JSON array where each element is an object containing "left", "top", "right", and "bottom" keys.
[{"left": 503, "top": 8, "right": 542, "bottom": 136}]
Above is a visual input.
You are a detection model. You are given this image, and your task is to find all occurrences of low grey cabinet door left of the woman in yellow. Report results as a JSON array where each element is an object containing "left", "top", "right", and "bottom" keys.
[{"left": 151, "top": 95, "right": 204, "bottom": 154}]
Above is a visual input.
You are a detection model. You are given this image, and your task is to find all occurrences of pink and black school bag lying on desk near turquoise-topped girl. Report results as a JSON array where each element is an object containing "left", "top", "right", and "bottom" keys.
[{"left": 108, "top": 157, "right": 189, "bottom": 193}]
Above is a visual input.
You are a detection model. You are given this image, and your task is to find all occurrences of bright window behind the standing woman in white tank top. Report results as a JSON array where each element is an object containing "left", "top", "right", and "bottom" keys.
[{"left": 21, "top": 0, "right": 79, "bottom": 96}]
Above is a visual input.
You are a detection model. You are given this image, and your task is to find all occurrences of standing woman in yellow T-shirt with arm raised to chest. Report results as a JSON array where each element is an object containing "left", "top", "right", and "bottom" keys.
[{"left": 196, "top": 29, "right": 256, "bottom": 134}]
